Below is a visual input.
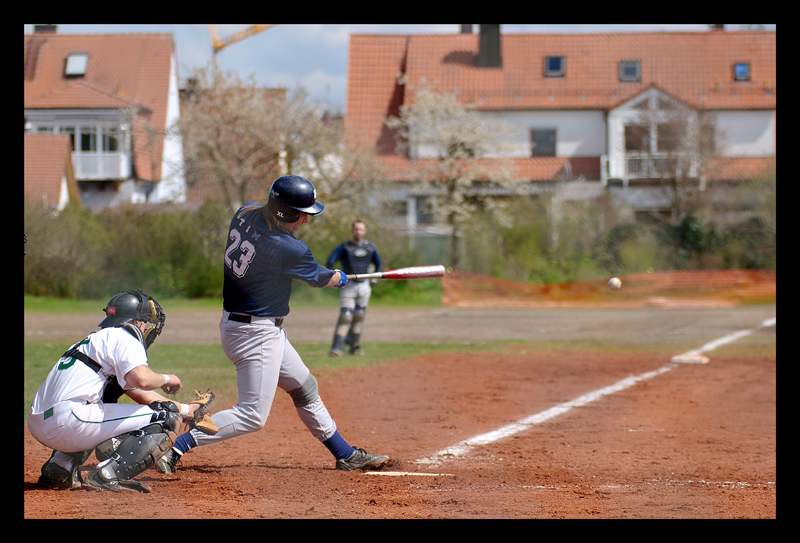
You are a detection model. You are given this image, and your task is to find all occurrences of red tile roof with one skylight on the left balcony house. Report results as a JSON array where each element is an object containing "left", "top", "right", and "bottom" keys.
[{"left": 24, "top": 34, "right": 174, "bottom": 181}]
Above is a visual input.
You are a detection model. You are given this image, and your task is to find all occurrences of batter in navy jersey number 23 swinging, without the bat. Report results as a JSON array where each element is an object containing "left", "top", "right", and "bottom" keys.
[{"left": 158, "top": 175, "right": 389, "bottom": 473}]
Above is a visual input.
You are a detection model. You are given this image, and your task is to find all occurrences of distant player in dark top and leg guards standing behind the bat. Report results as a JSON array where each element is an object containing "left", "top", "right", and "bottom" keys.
[{"left": 325, "top": 220, "right": 381, "bottom": 356}]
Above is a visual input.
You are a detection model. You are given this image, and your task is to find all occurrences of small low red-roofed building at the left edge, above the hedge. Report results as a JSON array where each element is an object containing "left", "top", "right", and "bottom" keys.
[{"left": 23, "top": 134, "right": 80, "bottom": 211}]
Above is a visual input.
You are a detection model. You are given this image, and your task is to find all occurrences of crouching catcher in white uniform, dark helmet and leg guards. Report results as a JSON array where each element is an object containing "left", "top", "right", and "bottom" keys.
[{"left": 28, "top": 290, "right": 218, "bottom": 492}]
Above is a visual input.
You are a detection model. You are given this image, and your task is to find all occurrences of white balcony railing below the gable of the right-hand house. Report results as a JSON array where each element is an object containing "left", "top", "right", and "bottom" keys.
[{"left": 600, "top": 152, "right": 698, "bottom": 186}]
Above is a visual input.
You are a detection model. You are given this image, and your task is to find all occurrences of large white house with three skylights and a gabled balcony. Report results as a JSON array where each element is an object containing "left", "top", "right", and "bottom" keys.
[{"left": 345, "top": 25, "right": 777, "bottom": 226}]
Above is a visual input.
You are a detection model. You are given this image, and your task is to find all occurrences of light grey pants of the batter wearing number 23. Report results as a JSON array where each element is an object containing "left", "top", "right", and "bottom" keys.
[{"left": 191, "top": 311, "right": 336, "bottom": 445}]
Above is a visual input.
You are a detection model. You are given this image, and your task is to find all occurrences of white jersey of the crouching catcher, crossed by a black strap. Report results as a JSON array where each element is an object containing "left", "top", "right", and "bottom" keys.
[{"left": 31, "top": 328, "right": 147, "bottom": 413}]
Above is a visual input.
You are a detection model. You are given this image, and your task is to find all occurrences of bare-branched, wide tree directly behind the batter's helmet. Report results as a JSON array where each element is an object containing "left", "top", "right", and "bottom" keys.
[{"left": 178, "top": 63, "right": 388, "bottom": 232}]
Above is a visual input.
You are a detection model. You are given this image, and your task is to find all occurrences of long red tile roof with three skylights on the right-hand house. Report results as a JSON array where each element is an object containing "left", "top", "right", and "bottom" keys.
[{"left": 345, "top": 31, "right": 777, "bottom": 179}]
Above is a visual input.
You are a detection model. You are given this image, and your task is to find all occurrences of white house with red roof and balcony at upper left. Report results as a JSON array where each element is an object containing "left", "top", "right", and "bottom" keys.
[{"left": 24, "top": 25, "right": 186, "bottom": 210}]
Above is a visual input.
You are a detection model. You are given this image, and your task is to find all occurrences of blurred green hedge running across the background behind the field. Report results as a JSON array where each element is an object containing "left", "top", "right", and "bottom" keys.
[{"left": 24, "top": 202, "right": 777, "bottom": 304}]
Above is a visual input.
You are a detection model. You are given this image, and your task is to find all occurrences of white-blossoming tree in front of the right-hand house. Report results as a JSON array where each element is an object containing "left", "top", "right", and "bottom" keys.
[{"left": 386, "top": 83, "right": 523, "bottom": 268}]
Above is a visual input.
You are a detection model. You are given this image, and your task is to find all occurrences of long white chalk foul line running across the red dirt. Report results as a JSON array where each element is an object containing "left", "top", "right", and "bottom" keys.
[{"left": 415, "top": 318, "right": 775, "bottom": 465}]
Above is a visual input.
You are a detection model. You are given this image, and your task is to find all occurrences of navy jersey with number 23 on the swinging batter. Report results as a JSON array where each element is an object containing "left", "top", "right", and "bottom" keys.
[{"left": 222, "top": 202, "right": 335, "bottom": 317}]
